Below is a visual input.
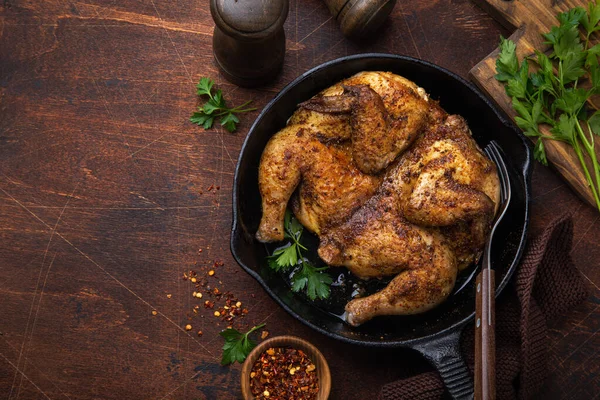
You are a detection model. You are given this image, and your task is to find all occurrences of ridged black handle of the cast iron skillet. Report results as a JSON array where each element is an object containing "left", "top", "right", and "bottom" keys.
[{"left": 412, "top": 329, "right": 473, "bottom": 400}]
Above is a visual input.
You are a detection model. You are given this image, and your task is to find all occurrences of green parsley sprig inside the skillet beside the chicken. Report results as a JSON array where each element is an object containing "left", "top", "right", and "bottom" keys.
[{"left": 268, "top": 210, "right": 333, "bottom": 300}]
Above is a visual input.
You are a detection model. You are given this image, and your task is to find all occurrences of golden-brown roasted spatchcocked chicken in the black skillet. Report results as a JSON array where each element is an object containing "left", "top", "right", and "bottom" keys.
[{"left": 256, "top": 72, "right": 500, "bottom": 326}]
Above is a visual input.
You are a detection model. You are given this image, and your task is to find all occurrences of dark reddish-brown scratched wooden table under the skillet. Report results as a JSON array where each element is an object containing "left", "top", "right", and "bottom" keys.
[{"left": 0, "top": 0, "right": 600, "bottom": 400}]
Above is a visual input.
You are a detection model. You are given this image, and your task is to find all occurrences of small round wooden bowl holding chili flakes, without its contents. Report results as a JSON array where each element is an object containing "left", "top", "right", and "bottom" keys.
[{"left": 242, "top": 336, "right": 331, "bottom": 400}]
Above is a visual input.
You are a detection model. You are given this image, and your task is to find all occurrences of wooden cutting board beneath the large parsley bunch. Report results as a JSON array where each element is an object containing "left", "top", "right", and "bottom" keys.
[{"left": 470, "top": 0, "right": 600, "bottom": 211}]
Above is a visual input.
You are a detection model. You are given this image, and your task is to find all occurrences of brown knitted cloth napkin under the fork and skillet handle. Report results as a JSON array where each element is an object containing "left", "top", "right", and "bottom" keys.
[{"left": 379, "top": 214, "right": 587, "bottom": 400}]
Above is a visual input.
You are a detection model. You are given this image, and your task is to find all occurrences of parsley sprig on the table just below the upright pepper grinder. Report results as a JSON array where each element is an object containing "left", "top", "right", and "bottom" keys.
[{"left": 190, "top": 77, "right": 256, "bottom": 132}]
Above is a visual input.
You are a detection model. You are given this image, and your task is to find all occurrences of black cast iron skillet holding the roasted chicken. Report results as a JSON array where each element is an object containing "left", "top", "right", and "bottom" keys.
[{"left": 231, "top": 54, "right": 531, "bottom": 398}]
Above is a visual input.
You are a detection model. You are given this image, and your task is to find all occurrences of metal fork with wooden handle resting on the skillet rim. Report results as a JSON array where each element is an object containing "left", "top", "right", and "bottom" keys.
[{"left": 475, "top": 141, "right": 511, "bottom": 400}]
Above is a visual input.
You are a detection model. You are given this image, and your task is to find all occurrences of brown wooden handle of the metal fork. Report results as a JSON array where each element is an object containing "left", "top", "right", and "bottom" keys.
[{"left": 475, "top": 268, "right": 496, "bottom": 400}]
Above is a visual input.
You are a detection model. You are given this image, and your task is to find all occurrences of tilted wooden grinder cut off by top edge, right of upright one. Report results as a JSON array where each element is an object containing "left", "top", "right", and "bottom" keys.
[{"left": 325, "top": 0, "right": 396, "bottom": 38}]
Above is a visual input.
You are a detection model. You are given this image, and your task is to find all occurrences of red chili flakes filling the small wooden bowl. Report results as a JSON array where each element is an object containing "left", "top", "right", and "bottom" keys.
[{"left": 250, "top": 346, "right": 319, "bottom": 400}]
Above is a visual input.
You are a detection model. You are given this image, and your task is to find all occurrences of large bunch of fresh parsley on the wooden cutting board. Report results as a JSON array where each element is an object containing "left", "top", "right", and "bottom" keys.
[{"left": 496, "top": 2, "right": 600, "bottom": 210}]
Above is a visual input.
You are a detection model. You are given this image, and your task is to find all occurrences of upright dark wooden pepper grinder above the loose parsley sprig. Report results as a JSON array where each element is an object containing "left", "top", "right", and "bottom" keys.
[{"left": 210, "top": 0, "right": 289, "bottom": 87}]
